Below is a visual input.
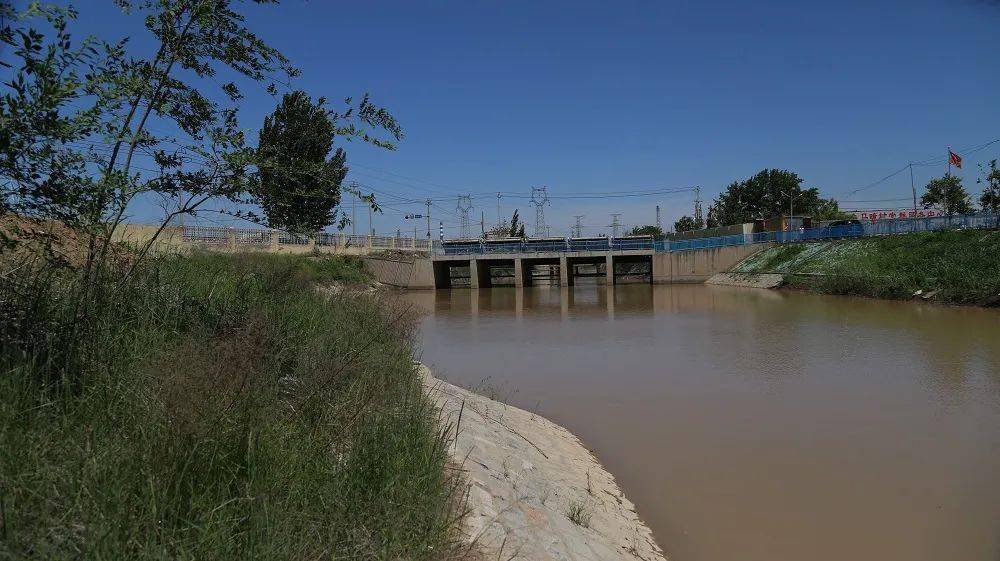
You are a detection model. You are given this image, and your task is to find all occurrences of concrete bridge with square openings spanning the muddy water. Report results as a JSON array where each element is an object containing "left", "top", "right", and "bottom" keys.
[{"left": 364, "top": 243, "right": 771, "bottom": 289}]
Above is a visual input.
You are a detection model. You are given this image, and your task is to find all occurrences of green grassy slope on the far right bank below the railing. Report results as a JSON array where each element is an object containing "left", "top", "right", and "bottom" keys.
[{"left": 736, "top": 230, "right": 1000, "bottom": 304}]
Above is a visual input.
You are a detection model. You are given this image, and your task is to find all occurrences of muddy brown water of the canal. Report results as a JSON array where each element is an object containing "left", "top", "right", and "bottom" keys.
[{"left": 405, "top": 285, "right": 1000, "bottom": 561}]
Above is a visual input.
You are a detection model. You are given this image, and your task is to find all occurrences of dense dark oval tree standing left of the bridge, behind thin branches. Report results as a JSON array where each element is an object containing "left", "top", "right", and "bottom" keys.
[{"left": 255, "top": 91, "right": 347, "bottom": 234}]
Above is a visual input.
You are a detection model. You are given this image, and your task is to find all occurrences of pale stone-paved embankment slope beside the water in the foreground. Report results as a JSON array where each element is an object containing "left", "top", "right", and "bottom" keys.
[{"left": 420, "top": 365, "right": 665, "bottom": 561}]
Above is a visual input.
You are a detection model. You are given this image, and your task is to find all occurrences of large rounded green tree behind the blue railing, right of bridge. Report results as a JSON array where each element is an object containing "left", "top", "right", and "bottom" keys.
[{"left": 709, "top": 169, "right": 845, "bottom": 226}]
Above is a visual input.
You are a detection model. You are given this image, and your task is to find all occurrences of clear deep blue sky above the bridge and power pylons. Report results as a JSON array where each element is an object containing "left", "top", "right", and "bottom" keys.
[{"left": 35, "top": 0, "right": 1000, "bottom": 235}]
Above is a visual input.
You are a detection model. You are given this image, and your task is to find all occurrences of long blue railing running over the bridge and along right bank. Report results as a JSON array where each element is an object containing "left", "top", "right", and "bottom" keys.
[{"left": 435, "top": 214, "right": 1000, "bottom": 255}]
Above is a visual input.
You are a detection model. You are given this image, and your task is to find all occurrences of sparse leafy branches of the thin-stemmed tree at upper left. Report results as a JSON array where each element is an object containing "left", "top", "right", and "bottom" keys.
[{"left": 0, "top": 0, "right": 402, "bottom": 277}]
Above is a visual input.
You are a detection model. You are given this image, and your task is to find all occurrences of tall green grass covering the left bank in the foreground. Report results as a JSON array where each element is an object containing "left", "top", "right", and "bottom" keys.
[{"left": 0, "top": 254, "right": 462, "bottom": 560}]
